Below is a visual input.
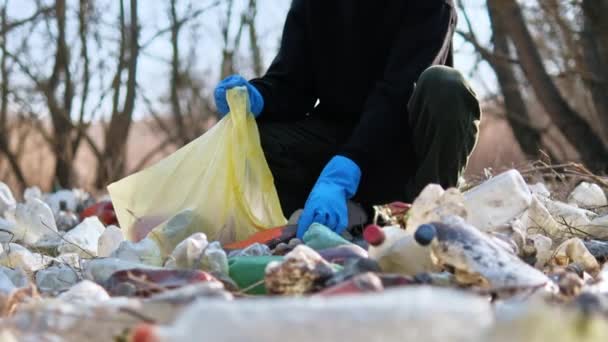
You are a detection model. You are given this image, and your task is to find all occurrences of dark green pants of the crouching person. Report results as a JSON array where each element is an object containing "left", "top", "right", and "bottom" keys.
[{"left": 259, "top": 66, "right": 481, "bottom": 216}]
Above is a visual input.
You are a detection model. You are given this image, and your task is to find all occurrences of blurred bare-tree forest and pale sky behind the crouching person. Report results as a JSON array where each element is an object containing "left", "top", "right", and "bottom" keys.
[{"left": 0, "top": 0, "right": 608, "bottom": 194}]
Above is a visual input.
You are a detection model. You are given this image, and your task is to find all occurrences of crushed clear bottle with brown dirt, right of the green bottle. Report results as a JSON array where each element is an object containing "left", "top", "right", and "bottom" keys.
[{"left": 264, "top": 245, "right": 334, "bottom": 295}]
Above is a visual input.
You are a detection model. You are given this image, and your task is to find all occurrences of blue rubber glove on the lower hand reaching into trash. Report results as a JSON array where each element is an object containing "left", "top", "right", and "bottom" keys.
[{"left": 298, "top": 156, "right": 361, "bottom": 239}]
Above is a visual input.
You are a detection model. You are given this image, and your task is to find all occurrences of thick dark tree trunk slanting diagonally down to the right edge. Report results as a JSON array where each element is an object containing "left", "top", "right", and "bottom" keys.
[{"left": 501, "top": 0, "right": 608, "bottom": 171}]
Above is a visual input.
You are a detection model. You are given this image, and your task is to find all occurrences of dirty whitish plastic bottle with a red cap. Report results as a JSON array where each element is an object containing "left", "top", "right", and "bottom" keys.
[{"left": 363, "top": 225, "right": 438, "bottom": 275}]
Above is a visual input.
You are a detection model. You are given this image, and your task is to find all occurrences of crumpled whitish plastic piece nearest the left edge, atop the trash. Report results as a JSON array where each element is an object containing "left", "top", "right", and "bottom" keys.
[{"left": 5, "top": 198, "right": 57, "bottom": 246}]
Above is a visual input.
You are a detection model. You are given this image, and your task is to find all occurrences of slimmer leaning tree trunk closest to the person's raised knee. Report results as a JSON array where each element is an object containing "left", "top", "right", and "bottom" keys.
[{"left": 487, "top": 0, "right": 542, "bottom": 159}]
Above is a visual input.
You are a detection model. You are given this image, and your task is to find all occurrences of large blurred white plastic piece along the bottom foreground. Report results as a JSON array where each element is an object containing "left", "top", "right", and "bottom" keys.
[{"left": 135, "top": 287, "right": 493, "bottom": 342}]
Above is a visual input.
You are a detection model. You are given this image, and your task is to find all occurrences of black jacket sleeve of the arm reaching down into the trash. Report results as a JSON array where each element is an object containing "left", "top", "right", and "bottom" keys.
[{"left": 339, "top": 0, "right": 456, "bottom": 174}]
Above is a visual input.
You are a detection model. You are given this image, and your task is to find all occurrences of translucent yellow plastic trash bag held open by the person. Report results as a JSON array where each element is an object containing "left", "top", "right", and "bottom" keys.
[{"left": 108, "top": 88, "right": 286, "bottom": 243}]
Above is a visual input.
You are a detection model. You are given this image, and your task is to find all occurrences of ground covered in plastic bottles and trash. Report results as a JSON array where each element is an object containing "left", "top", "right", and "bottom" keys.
[{"left": 0, "top": 163, "right": 608, "bottom": 342}]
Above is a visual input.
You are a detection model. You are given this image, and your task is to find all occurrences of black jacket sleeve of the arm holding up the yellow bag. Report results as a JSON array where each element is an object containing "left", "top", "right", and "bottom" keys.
[{"left": 251, "top": 0, "right": 317, "bottom": 120}]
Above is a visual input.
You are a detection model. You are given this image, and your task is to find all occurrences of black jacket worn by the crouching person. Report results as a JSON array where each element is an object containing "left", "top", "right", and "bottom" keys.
[{"left": 252, "top": 0, "right": 456, "bottom": 173}]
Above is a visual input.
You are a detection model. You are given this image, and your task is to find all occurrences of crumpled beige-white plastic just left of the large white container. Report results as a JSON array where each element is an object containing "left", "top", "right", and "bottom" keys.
[{"left": 407, "top": 184, "right": 469, "bottom": 232}]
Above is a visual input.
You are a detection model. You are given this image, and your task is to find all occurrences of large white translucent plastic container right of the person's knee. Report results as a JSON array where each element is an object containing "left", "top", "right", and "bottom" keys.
[{"left": 464, "top": 170, "right": 532, "bottom": 231}]
